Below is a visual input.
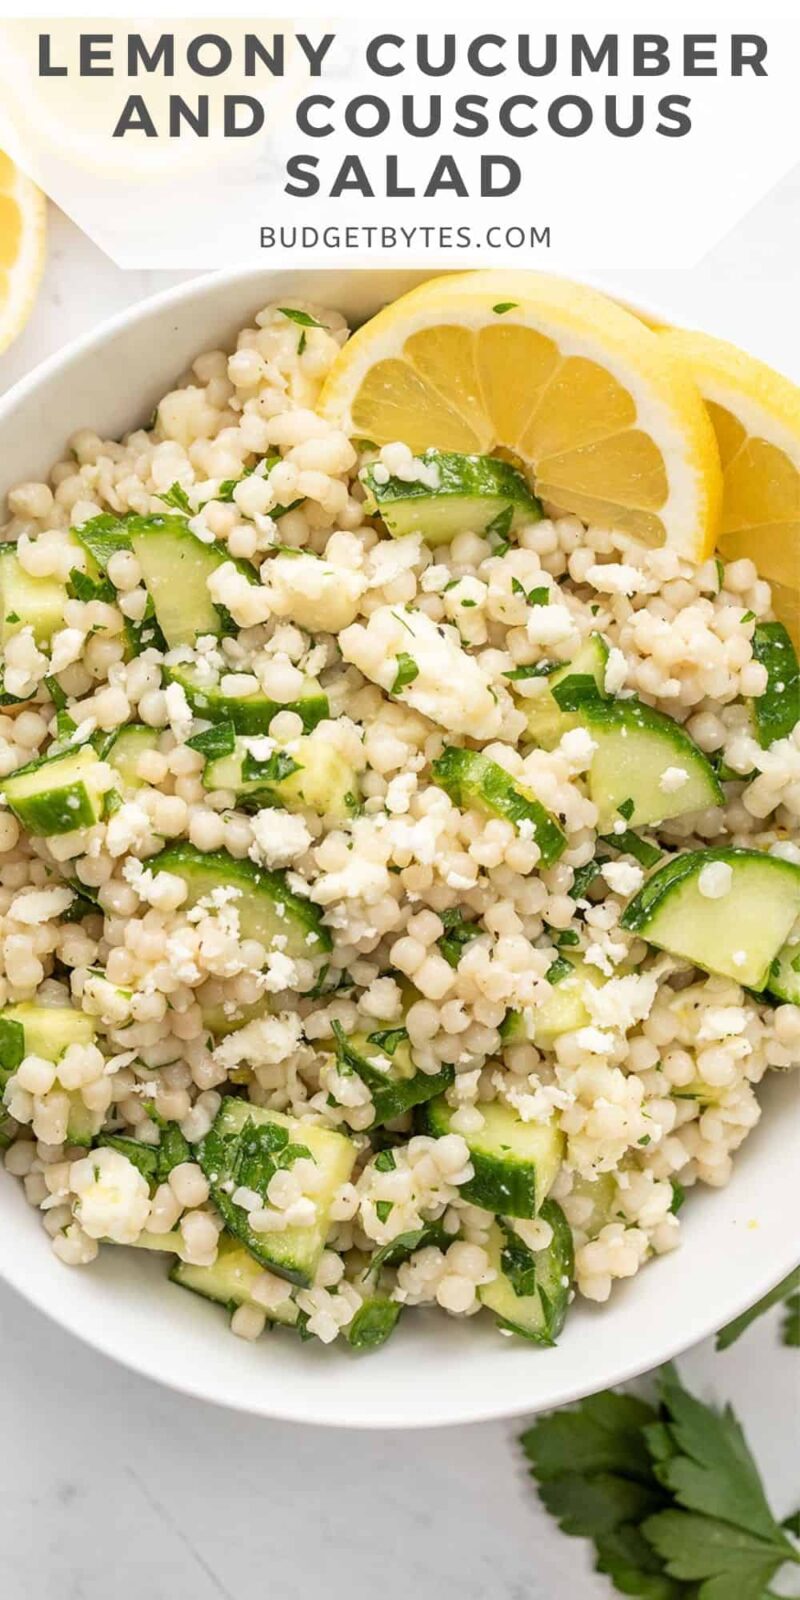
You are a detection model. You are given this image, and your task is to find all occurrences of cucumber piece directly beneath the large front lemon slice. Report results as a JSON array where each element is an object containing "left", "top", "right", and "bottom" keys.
[{"left": 360, "top": 450, "right": 542, "bottom": 546}]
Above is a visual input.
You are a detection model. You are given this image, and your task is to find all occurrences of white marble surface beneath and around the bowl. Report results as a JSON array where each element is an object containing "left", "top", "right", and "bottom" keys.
[{"left": 0, "top": 193, "right": 800, "bottom": 1600}]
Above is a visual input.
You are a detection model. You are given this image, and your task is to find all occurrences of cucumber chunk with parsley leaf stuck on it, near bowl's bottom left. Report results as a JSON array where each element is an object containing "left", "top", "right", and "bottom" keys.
[{"left": 197, "top": 1096, "right": 355, "bottom": 1286}]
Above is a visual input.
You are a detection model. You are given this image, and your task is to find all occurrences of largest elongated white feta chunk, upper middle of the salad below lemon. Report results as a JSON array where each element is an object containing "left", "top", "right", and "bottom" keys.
[{"left": 339, "top": 605, "right": 502, "bottom": 739}]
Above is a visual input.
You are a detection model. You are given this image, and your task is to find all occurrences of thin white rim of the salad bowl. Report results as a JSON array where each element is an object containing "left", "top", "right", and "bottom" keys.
[{"left": 0, "top": 264, "right": 800, "bottom": 1430}]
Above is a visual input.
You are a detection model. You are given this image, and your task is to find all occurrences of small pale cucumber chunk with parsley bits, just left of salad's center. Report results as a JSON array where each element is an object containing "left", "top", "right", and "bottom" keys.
[{"left": 203, "top": 734, "right": 360, "bottom": 818}]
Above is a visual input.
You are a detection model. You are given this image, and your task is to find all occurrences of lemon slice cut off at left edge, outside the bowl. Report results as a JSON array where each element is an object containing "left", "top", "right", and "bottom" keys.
[{"left": 0, "top": 150, "right": 45, "bottom": 350}]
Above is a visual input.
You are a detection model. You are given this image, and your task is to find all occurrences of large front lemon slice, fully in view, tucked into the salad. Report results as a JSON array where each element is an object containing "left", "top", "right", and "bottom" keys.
[{"left": 322, "top": 272, "right": 722, "bottom": 562}]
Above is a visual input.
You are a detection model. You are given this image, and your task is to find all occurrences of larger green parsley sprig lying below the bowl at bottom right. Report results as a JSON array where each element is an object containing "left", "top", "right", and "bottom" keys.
[{"left": 520, "top": 1366, "right": 800, "bottom": 1600}]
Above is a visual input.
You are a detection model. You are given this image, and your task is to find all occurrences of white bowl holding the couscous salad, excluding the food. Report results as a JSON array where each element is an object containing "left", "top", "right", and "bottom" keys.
[{"left": 0, "top": 270, "right": 800, "bottom": 1427}]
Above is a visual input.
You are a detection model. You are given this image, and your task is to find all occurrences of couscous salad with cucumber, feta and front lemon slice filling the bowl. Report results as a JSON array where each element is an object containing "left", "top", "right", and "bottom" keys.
[{"left": 0, "top": 274, "right": 800, "bottom": 1349}]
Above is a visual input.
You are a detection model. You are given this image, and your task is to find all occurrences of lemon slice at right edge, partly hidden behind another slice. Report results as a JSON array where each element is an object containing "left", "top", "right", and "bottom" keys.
[{"left": 661, "top": 328, "right": 800, "bottom": 646}]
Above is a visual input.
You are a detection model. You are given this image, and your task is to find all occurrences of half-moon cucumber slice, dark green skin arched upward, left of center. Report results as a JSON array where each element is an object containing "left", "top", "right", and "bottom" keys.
[{"left": 150, "top": 845, "right": 331, "bottom": 958}]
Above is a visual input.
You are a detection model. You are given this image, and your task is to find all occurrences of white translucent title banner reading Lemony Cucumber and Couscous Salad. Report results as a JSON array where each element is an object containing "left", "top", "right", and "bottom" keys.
[{"left": 0, "top": 12, "right": 800, "bottom": 269}]
